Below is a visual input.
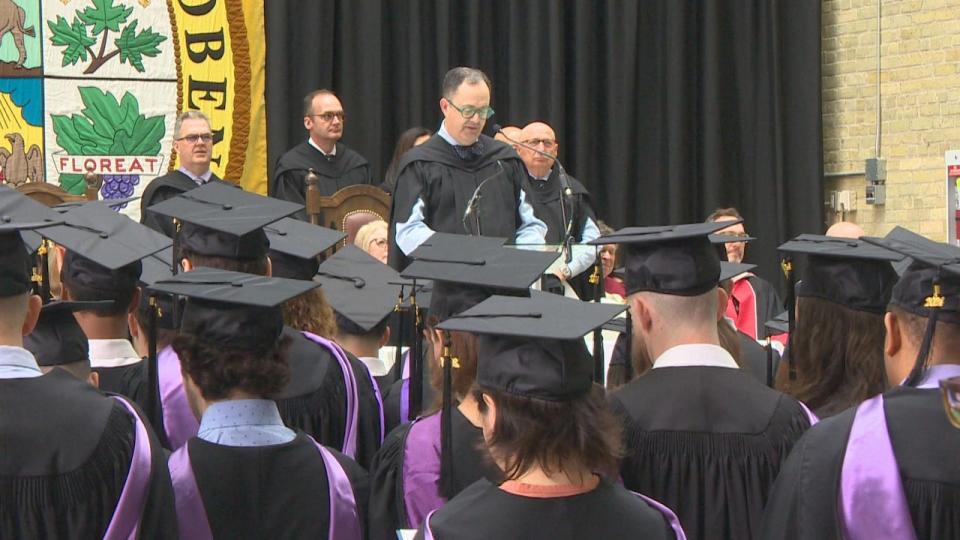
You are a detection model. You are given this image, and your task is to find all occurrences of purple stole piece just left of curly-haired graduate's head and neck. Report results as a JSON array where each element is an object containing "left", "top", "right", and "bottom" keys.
[{"left": 157, "top": 345, "right": 200, "bottom": 450}]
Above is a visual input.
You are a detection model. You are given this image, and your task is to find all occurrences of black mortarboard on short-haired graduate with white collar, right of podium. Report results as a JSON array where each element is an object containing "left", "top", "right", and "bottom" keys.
[{"left": 589, "top": 221, "right": 739, "bottom": 296}]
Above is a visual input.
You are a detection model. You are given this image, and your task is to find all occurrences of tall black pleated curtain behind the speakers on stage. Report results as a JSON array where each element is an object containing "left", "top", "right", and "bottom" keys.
[{"left": 264, "top": 0, "right": 823, "bottom": 283}]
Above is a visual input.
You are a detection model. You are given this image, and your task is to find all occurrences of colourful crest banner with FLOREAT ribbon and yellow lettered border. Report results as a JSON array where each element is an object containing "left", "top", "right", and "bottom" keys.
[{"left": 0, "top": 0, "right": 267, "bottom": 217}]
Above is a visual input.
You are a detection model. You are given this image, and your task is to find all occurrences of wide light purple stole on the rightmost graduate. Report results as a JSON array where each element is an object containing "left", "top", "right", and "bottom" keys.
[{"left": 837, "top": 365, "right": 960, "bottom": 540}]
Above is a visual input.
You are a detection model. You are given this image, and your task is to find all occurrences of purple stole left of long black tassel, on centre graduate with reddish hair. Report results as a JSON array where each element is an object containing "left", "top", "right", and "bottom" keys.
[{"left": 400, "top": 413, "right": 447, "bottom": 529}]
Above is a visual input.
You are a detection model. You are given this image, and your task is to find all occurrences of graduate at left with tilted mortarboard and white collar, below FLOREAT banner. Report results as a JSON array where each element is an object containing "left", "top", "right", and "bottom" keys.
[{"left": 45, "top": 201, "right": 172, "bottom": 396}]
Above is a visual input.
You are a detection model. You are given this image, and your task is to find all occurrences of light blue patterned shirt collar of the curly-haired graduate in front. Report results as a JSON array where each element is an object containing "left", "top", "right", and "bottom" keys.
[{"left": 197, "top": 399, "right": 297, "bottom": 446}]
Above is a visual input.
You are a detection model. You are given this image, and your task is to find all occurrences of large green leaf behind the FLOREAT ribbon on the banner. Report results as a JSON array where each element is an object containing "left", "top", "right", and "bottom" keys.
[{"left": 50, "top": 87, "right": 166, "bottom": 198}]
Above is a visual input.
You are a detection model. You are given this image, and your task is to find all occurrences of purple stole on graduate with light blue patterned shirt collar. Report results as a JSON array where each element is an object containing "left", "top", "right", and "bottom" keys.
[{"left": 169, "top": 437, "right": 362, "bottom": 540}]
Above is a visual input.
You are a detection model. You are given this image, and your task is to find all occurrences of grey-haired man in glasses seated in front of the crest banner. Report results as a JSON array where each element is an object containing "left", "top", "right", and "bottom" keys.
[{"left": 140, "top": 111, "right": 221, "bottom": 238}]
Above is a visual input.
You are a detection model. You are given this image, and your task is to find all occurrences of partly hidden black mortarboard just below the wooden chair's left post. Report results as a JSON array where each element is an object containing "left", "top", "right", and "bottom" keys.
[{"left": 263, "top": 218, "right": 347, "bottom": 279}]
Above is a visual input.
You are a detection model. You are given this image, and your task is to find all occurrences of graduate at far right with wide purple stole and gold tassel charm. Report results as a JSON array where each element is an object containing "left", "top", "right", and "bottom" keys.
[{"left": 762, "top": 228, "right": 960, "bottom": 540}]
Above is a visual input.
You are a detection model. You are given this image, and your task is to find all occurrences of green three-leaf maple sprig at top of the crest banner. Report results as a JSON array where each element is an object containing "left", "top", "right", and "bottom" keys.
[{"left": 47, "top": 0, "right": 167, "bottom": 75}]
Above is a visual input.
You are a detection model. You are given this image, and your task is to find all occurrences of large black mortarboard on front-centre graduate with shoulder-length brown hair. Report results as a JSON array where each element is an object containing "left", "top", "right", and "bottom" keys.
[{"left": 439, "top": 294, "right": 626, "bottom": 401}]
